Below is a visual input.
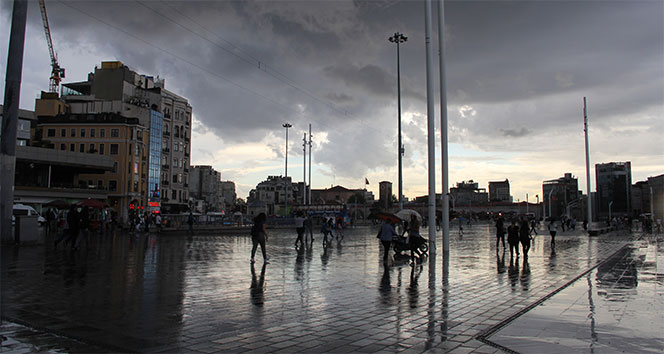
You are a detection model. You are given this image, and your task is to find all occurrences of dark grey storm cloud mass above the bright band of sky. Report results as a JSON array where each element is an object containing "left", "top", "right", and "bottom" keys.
[{"left": 0, "top": 1, "right": 664, "bottom": 188}]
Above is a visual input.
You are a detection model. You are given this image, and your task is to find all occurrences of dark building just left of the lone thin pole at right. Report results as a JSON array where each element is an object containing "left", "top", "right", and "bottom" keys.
[{"left": 542, "top": 173, "right": 585, "bottom": 220}]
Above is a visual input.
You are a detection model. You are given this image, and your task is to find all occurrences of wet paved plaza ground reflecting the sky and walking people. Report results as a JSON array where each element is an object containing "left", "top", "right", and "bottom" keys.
[{"left": 2, "top": 224, "right": 664, "bottom": 353}]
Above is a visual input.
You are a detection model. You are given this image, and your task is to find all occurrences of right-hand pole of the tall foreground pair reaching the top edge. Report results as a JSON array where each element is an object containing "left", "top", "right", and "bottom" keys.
[{"left": 438, "top": 0, "right": 450, "bottom": 253}]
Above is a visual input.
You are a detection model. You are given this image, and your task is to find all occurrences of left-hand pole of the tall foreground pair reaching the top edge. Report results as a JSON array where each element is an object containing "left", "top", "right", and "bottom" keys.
[{"left": 424, "top": 0, "right": 436, "bottom": 258}]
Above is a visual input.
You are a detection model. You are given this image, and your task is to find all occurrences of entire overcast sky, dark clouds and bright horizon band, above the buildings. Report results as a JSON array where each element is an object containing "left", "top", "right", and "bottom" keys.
[{"left": 0, "top": 0, "right": 664, "bottom": 201}]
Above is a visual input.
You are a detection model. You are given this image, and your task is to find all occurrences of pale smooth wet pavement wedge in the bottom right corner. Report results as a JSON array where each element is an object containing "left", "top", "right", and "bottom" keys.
[{"left": 489, "top": 238, "right": 664, "bottom": 353}]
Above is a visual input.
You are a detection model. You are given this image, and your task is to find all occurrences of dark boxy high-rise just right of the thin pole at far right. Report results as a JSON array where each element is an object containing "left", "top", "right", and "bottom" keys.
[{"left": 595, "top": 161, "right": 632, "bottom": 219}]
